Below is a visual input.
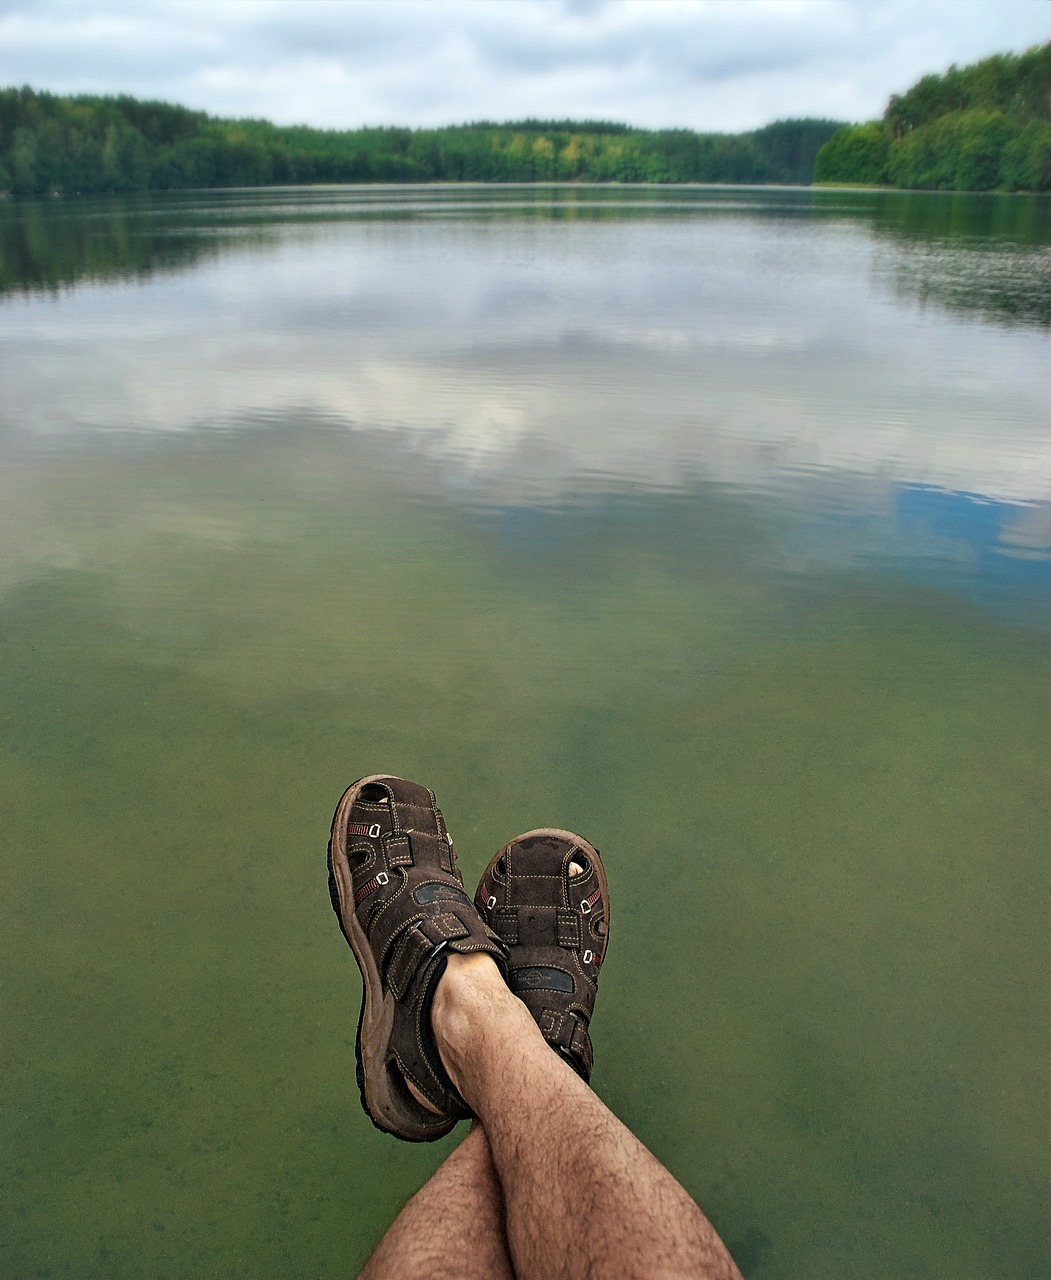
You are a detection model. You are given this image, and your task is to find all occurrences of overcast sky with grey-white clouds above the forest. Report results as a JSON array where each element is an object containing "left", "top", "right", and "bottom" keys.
[{"left": 0, "top": 0, "right": 1051, "bottom": 132}]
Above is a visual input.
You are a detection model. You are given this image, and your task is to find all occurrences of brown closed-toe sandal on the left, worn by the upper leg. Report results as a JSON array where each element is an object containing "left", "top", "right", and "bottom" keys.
[{"left": 329, "top": 774, "right": 507, "bottom": 1142}]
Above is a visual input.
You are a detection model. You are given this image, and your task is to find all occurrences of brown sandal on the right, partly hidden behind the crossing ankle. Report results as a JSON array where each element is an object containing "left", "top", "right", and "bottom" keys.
[{"left": 475, "top": 827, "right": 609, "bottom": 1083}]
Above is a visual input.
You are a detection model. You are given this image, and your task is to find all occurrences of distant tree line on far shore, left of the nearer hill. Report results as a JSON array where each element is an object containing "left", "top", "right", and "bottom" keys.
[{"left": 0, "top": 87, "right": 841, "bottom": 196}]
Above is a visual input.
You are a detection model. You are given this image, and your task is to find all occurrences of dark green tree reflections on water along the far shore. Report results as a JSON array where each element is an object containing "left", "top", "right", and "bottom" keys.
[{"left": 0, "top": 184, "right": 1051, "bottom": 328}]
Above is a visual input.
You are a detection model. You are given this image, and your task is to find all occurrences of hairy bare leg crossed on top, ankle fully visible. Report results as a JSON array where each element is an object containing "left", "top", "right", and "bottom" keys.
[{"left": 430, "top": 955, "right": 741, "bottom": 1280}]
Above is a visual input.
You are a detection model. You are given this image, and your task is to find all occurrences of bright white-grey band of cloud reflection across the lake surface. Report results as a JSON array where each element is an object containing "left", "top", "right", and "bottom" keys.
[{"left": 0, "top": 192, "right": 1051, "bottom": 609}]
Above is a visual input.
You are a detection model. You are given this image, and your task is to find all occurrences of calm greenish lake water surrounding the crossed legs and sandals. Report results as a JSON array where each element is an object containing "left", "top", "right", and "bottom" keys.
[{"left": 0, "top": 187, "right": 1051, "bottom": 1280}]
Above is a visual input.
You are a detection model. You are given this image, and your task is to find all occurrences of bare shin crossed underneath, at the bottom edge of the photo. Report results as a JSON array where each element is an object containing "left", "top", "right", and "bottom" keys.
[{"left": 358, "top": 1121, "right": 512, "bottom": 1280}]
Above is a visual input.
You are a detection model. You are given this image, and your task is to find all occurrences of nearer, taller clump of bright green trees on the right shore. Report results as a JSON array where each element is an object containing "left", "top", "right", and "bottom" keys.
[{"left": 814, "top": 42, "right": 1051, "bottom": 192}]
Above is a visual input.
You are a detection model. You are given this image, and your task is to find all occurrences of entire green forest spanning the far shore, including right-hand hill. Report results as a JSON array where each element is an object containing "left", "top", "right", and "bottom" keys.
[{"left": 0, "top": 42, "right": 1051, "bottom": 196}]
